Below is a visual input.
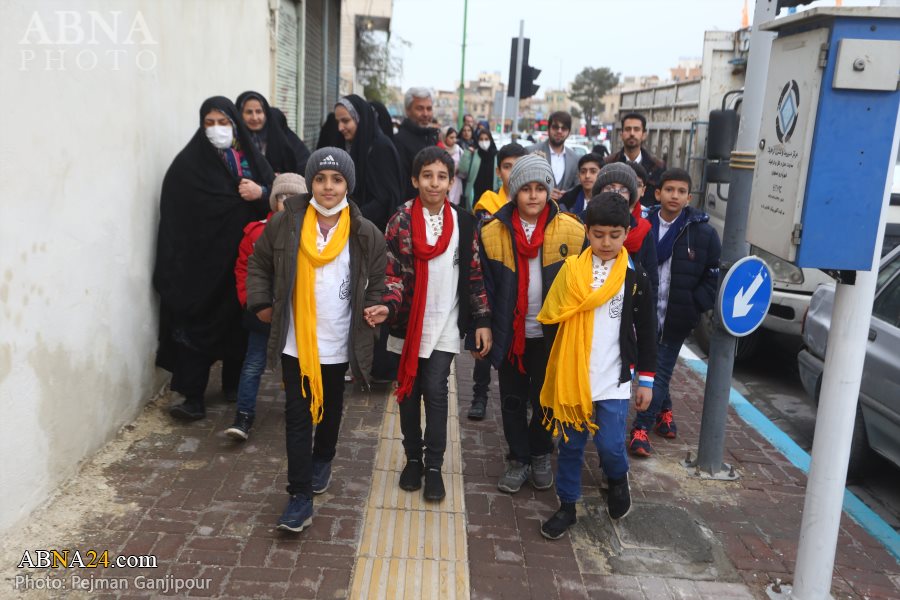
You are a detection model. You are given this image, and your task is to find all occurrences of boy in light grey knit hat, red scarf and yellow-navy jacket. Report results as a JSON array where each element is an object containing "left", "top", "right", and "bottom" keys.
[{"left": 481, "top": 154, "right": 585, "bottom": 494}]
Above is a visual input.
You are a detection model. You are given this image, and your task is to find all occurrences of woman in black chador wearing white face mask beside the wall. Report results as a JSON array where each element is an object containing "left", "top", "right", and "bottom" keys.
[{"left": 153, "top": 96, "right": 274, "bottom": 420}]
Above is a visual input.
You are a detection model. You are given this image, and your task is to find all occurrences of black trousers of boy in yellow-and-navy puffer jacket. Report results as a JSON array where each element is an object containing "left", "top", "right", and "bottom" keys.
[{"left": 499, "top": 338, "right": 553, "bottom": 465}]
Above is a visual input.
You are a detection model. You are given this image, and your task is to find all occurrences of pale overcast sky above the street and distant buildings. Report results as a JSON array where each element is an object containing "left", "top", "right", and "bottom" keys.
[{"left": 391, "top": 0, "right": 864, "bottom": 95}]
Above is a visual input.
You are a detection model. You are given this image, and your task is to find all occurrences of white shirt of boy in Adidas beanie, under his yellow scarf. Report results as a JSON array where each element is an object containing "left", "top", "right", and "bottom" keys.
[{"left": 282, "top": 219, "right": 351, "bottom": 365}]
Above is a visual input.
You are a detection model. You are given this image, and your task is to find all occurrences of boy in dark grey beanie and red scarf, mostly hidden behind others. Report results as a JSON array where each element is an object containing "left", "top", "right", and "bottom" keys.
[{"left": 592, "top": 163, "right": 659, "bottom": 301}]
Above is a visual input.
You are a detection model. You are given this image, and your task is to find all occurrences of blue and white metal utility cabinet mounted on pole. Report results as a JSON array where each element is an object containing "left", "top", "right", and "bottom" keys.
[{"left": 747, "top": 7, "right": 900, "bottom": 271}]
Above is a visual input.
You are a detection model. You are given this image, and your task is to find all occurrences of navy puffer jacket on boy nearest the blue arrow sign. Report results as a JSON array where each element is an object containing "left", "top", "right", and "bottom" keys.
[{"left": 647, "top": 206, "right": 722, "bottom": 342}]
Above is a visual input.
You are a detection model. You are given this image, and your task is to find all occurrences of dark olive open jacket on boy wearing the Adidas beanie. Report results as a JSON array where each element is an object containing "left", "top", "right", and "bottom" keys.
[{"left": 247, "top": 194, "right": 387, "bottom": 385}]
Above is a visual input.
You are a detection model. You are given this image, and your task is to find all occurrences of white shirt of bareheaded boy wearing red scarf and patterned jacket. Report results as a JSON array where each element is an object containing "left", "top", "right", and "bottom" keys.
[{"left": 387, "top": 207, "right": 459, "bottom": 358}]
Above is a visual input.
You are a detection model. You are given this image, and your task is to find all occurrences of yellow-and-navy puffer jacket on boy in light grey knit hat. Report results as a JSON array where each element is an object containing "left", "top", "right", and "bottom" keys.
[{"left": 480, "top": 201, "right": 587, "bottom": 369}]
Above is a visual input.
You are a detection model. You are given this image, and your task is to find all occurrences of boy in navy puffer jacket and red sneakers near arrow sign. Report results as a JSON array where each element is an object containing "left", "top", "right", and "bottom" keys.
[{"left": 628, "top": 169, "right": 722, "bottom": 457}]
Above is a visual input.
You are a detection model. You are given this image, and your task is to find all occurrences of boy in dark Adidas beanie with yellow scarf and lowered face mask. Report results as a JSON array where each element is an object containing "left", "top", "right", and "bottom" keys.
[{"left": 247, "top": 147, "right": 387, "bottom": 532}]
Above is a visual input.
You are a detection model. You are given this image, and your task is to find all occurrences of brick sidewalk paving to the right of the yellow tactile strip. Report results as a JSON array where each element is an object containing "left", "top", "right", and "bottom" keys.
[{"left": 457, "top": 356, "right": 900, "bottom": 599}]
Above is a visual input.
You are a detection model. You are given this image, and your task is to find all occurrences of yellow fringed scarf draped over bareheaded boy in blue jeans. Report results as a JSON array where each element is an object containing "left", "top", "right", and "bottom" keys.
[{"left": 537, "top": 247, "right": 628, "bottom": 440}]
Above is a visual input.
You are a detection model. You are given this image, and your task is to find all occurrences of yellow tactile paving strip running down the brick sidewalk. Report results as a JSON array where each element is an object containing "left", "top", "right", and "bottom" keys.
[{"left": 350, "top": 366, "right": 469, "bottom": 600}]
